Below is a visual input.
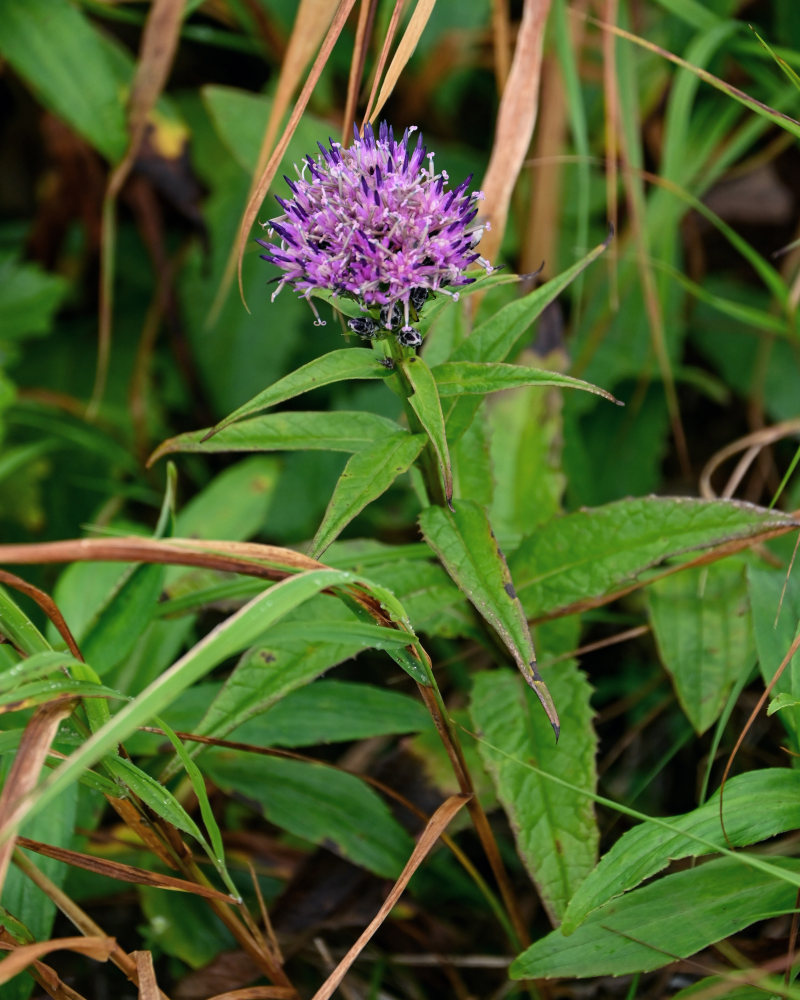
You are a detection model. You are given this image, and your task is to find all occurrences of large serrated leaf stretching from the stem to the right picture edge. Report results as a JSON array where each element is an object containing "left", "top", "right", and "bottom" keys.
[{"left": 509, "top": 497, "right": 795, "bottom": 618}]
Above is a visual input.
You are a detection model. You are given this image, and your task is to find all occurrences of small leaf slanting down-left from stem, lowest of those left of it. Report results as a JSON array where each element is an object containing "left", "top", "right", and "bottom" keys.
[{"left": 310, "top": 432, "right": 426, "bottom": 559}]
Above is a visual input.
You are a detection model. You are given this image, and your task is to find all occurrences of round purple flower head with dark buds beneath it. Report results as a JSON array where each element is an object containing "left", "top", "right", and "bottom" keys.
[{"left": 257, "top": 122, "right": 492, "bottom": 346}]
